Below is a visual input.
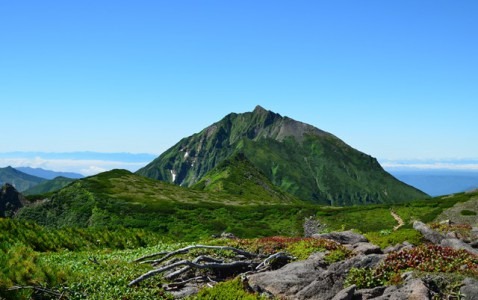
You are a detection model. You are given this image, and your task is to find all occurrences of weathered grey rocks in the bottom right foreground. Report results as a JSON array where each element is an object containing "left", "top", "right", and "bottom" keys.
[{"left": 248, "top": 222, "right": 478, "bottom": 300}]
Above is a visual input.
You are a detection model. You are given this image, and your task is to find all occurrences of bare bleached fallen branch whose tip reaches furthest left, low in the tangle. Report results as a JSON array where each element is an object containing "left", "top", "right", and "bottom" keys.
[{"left": 128, "top": 258, "right": 257, "bottom": 286}]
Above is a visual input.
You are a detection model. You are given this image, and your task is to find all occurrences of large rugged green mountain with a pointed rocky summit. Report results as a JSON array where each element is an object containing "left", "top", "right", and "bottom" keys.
[{"left": 137, "top": 106, "right": 427, "bottom": 206}]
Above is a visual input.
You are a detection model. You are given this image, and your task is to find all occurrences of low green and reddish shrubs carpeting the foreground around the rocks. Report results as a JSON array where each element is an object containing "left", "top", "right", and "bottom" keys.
[{"left": 0, "top": 189, "right": 478, "bottom": 299}]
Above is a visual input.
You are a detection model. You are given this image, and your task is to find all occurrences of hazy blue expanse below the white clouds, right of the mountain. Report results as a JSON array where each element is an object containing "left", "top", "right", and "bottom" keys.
[{"left": 391, "top": 170, "right": 478, "bottom": 196}]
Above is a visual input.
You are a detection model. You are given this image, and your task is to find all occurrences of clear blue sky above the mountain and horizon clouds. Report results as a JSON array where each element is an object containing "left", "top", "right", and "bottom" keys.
[{"left": 0, "top": 0, "right": 478, "bottom": 173}]
